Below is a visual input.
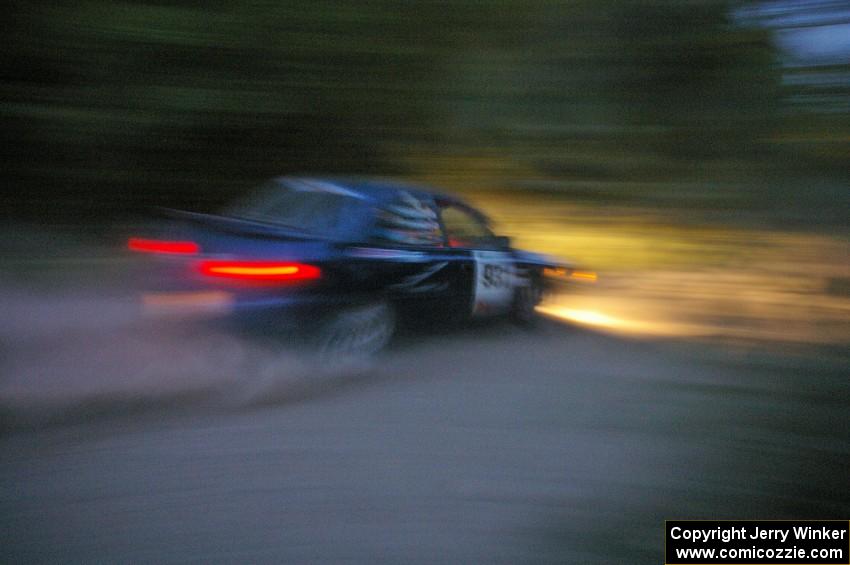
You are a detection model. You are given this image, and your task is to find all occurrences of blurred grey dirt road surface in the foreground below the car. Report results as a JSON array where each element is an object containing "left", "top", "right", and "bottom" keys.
[{"left": 0, "top": 316, "right": 850, "bottom": 563}]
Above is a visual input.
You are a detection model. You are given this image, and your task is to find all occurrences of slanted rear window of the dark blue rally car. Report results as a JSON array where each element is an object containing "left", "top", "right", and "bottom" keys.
[{"left": 227, "top": 180, "right": 360, "bottom": 234}]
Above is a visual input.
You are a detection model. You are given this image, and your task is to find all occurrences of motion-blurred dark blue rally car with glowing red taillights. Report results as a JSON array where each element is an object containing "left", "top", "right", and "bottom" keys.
[{"left": 128, "top": 177, "right": 588, "bottom": 354}]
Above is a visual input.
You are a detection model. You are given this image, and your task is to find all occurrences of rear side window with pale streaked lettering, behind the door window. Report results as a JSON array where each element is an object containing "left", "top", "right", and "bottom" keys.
[{"left": 373, "top": 191, "right": 443, "bottom": 246}]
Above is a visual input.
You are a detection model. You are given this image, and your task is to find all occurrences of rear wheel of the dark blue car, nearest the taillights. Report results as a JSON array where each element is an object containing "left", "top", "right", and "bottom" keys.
[{"left": 317, "top": 301, "right": 396, "bottom": 364}]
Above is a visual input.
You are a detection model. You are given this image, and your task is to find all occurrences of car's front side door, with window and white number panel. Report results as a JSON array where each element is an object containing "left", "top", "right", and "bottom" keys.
[{"left": 440, "top": 201, "right": 517, "bottom": 317}]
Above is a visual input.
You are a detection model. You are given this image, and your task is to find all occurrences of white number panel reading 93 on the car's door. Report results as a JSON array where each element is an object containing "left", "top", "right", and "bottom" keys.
[{"left": 472, "top": 251, "right": 516, "bottom": 316}]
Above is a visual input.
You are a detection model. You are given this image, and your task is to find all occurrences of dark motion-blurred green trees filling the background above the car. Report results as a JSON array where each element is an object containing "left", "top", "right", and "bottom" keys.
[{"left": 0, "top": 0, "right": 836, "bottom": 221}]
